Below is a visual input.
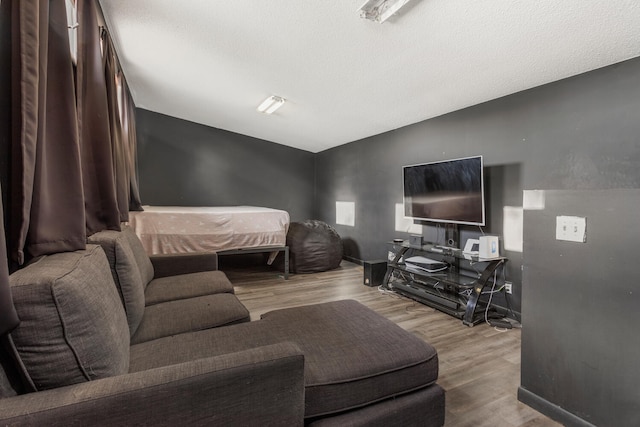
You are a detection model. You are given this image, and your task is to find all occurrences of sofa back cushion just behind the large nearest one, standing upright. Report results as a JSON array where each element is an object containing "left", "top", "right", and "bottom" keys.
[{"left": 88, "top": 230, "right": 153, "bottom": 335}]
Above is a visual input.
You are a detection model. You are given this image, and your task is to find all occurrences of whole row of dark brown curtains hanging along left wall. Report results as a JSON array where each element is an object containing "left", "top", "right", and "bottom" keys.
[{"left": 0, "top": 0, "right": 141, "bottom": 334}]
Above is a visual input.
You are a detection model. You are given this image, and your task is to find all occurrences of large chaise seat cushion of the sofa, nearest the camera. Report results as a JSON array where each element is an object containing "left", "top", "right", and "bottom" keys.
[{"left": 130, "top": 300, "right": 438, "bottom": 418}]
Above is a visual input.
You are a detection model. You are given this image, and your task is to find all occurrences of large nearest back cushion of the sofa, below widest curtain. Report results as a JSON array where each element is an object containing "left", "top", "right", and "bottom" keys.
[{"left": 9, "top": 245, "right": 130, "bottom": 390}]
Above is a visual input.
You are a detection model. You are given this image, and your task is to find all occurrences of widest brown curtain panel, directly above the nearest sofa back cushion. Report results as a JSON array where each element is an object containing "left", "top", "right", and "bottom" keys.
[{"left": 8, "top": 0, "right": 86, "bottom": 264}]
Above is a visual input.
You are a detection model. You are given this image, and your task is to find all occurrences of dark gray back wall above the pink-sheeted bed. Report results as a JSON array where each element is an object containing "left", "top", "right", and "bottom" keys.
[{"left": 136, "top": 109, "right": 314, "bottom": 221}]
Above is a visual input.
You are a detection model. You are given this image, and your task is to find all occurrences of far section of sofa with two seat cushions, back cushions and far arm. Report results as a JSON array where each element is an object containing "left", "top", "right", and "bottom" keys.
[{"left": 89, "top": 227, "right": 250, "bottom": 344}]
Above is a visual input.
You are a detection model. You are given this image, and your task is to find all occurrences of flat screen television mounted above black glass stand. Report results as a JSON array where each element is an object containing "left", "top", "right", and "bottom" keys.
[{"left": 403, "top": 156, "right": 485, "bottom": 225}]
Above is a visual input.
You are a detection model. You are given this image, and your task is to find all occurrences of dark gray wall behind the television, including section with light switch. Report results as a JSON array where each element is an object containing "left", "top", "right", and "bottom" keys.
[{"left": 316, "top": 59, "right": 640, "bottom": 426}]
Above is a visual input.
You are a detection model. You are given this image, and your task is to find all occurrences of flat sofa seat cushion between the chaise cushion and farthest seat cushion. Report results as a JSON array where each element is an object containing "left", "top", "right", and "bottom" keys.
[{"left": 131, "top": 293, "right": 250, "bottom": 344}]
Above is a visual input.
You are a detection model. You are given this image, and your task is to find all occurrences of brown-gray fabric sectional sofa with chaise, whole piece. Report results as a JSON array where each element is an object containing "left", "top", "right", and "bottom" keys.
[{"left": 0, "top": 228, "right": 444, "bottom": 426}]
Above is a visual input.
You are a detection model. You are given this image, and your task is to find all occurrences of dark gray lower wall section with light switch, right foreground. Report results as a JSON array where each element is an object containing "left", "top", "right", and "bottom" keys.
[{"left": 519, "top": 189, "right": 640, "bottom": 426}]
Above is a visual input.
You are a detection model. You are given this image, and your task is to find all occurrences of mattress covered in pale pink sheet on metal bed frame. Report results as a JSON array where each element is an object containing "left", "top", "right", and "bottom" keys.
[{"left": 129, "top": 206, "right": 290, "bottom": 255}]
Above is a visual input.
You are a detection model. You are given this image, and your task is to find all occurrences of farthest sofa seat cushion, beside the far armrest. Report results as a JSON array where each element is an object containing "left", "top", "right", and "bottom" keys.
[{"left": 144, "top": 270, "right": 234, "bottom": 306}]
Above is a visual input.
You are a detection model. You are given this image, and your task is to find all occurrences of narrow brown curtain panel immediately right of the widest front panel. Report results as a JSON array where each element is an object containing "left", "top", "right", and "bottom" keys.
[{"left": 77, "top": 0, "right": 120, "bottom": 235}]
